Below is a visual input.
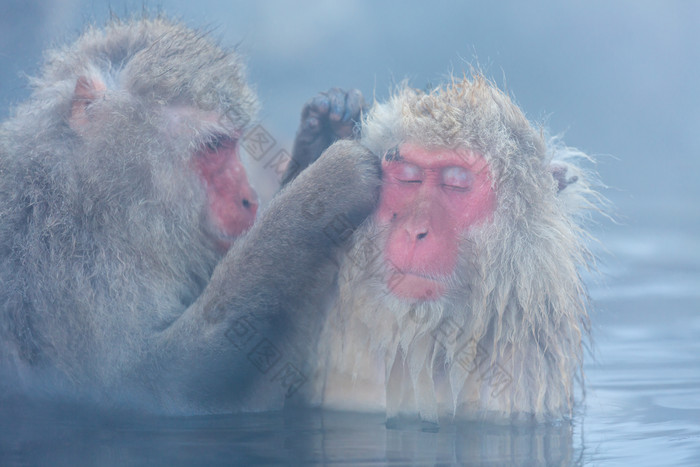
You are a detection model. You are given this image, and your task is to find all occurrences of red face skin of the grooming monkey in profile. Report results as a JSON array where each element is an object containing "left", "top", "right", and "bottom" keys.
[{"left": 194, "top": 137, "right": 258, "bottom": 251}]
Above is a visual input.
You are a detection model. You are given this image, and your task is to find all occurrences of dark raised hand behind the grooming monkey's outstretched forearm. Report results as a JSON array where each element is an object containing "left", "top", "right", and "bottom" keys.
[{"left": 282, "top": 88, "right": 366, "bottom": 186}]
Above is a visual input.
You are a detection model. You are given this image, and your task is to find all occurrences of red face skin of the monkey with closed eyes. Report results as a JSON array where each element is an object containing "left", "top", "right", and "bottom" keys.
[{"left": 375, "top": 143, "right": 496, "bottom": 301}]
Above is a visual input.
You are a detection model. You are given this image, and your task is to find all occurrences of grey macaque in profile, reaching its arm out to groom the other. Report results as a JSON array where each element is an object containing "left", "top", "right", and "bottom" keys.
[{"left": 0, "top": 18, "right": 380, "bottom": 413}]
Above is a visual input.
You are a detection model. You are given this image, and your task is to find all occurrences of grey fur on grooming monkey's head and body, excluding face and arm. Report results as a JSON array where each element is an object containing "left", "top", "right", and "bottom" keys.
[{"left": 0, "top": 18, "right": 257, "bottom": 394}]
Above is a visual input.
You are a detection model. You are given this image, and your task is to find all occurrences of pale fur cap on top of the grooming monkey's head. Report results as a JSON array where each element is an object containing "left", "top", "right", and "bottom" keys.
[{"left": 32, "top": 17, "right": 258, "bottom": 128}]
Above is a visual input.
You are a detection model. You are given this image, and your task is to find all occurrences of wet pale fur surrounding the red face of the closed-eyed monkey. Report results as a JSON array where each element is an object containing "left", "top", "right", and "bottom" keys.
[{"left": 316, "top": 75, "right": 598, "bottom": 421}]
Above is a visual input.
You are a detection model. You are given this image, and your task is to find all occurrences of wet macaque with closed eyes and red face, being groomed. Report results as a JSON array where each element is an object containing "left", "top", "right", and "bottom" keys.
[{"left": 296, "top": 75, "right": 596, "bottom": 423}]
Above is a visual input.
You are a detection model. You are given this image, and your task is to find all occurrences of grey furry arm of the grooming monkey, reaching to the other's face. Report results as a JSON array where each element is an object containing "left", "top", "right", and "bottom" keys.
[{"left": 151, "top": 141, "right": 380, "bottom": 411}]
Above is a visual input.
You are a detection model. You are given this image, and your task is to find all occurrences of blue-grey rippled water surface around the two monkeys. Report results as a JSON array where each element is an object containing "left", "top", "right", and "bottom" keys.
[{"left": 0, "top": 209, "right": 700, "bottom": 466}]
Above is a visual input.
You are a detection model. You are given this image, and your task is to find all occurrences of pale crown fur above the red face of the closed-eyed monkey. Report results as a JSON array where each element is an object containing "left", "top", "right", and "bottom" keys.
[{"left": 362, "top": 74, "right": 546, "bottom": 170}]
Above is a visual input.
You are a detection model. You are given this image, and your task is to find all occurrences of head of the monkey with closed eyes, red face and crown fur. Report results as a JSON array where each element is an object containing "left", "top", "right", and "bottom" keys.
[{"left": 363, "top": 76, "right": 578, "bottom": 308}]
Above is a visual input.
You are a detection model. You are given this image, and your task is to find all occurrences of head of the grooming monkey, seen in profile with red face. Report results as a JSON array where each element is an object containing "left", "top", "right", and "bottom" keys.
[{"left": 50, "top": 19, "right": 257, "bottom": 251}]
